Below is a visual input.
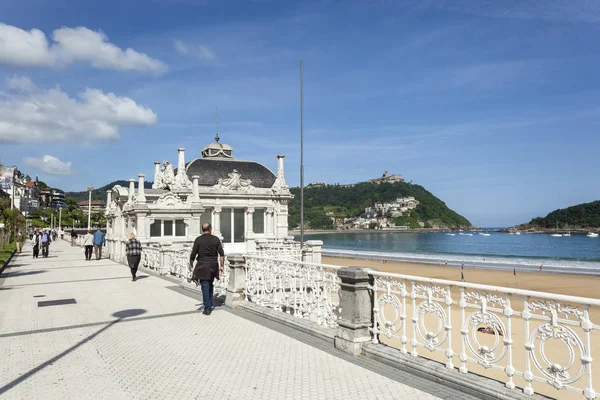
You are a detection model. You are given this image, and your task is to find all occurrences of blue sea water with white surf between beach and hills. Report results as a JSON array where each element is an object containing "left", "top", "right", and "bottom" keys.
[{"left": 296, "top": 231, "right": 600, "bottom": 275}]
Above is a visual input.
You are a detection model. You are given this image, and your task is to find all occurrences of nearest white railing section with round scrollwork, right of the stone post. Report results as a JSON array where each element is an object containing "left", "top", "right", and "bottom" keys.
[{"left": 369, "top": 271, "right": 600, "bottom": 399}]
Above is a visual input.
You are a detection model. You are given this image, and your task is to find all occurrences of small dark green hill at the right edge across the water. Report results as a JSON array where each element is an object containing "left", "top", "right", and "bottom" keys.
[{"left": 521, "top": 200, "right": 600, "bottom": 229}]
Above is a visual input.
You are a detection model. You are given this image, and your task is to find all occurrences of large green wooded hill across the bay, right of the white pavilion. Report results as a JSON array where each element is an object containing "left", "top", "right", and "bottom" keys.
[{"left": 289, "top": 182, "right": 471, "bottom": 229}]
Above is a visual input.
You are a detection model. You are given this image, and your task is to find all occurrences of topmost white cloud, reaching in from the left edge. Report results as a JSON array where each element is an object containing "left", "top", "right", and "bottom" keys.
[{"left": 0, "top": 23, "right": 167, "bottom": 75}]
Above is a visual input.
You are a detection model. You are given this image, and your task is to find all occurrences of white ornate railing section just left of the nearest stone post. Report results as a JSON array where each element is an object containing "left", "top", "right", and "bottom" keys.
[{"left": 245, "top": 255, "right": 341, "bottom": 328}]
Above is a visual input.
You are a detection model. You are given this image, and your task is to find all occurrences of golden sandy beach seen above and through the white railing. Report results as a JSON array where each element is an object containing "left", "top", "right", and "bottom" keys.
[{"left": 322, "top": 257, "right": 600, "bottom": 400}]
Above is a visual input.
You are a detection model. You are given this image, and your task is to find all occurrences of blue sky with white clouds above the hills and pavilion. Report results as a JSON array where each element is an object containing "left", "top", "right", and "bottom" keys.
[{"left": 0, "top": 0, "right": 600, "bottom": 226}]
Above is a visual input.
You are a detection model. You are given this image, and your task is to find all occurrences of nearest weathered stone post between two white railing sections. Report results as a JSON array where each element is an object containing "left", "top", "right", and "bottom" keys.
[{"left": 334, "top": 267, "right": 373, "bottom": 355}]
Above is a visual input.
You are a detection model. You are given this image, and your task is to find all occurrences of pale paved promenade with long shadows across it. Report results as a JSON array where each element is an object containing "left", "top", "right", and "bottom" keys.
[{"left": 0, "top": 241, "right": 447, "bottom": 400}]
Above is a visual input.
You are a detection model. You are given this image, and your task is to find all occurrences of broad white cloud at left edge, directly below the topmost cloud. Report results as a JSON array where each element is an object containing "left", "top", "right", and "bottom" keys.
[{"left": 0, "top": 77, "right": 156, "bottom": 143}]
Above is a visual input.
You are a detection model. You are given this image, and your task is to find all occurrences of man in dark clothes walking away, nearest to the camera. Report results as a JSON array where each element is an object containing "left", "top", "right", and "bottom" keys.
[{"left": 190, "top": 222, "right": 225, "bottom": 315}]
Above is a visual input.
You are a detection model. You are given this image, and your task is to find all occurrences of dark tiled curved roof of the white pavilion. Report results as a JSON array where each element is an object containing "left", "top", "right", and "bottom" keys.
[{"left": 186, "top": 158, "right": 276, "bottom": 188}]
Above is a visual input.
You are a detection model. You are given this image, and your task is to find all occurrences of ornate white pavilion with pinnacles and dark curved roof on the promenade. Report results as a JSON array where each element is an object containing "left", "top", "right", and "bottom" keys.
[{"left": 106, "top": 136, "right": 293, "bottom": 261}]
